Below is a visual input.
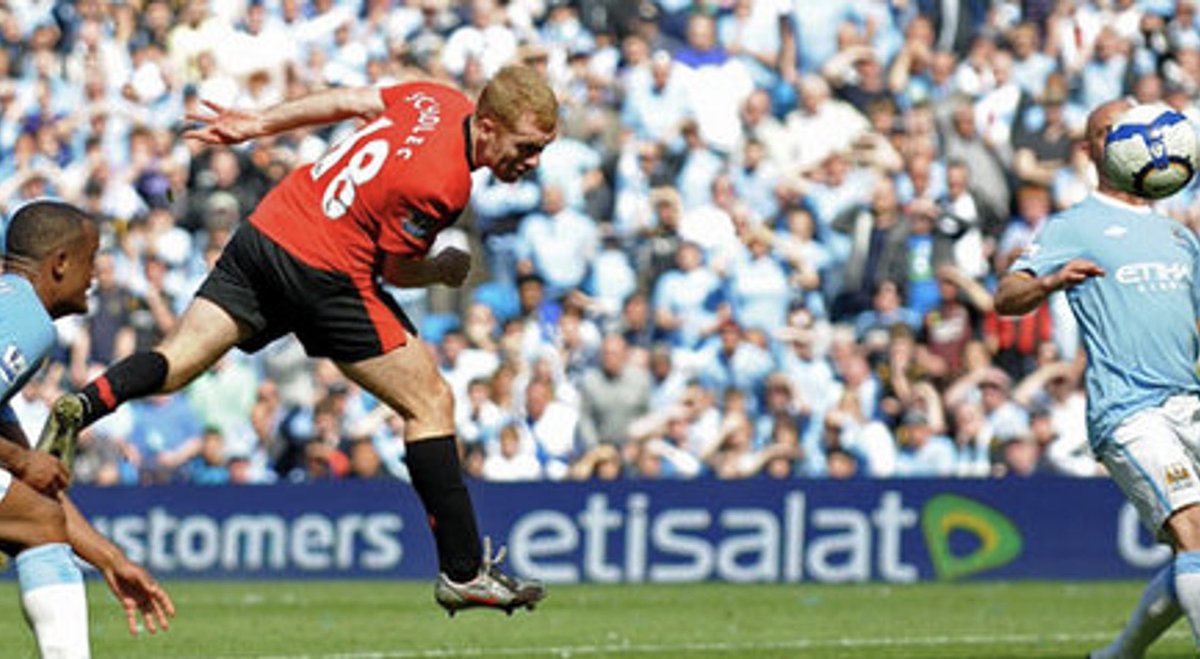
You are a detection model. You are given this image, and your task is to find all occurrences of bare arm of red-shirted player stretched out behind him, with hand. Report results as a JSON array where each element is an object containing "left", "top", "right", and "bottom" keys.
[{"left": 184, "top": 86, "right": 385, "bottom": 144}]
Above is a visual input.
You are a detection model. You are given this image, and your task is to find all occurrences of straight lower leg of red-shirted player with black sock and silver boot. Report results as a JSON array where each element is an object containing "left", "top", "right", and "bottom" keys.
[{"left": 338, "top": 337, "right": 545, "bottom": 616}]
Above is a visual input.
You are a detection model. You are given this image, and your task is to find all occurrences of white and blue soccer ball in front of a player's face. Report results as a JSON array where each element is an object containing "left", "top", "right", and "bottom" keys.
[{"left": 1104, "top": 103, "right": 1200, "bottom": 199}]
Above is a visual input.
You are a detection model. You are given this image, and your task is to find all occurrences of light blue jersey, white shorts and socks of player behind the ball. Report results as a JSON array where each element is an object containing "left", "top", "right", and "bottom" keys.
[{"left": 1013, "top": 192, "right": 1200, "bottom": 659}]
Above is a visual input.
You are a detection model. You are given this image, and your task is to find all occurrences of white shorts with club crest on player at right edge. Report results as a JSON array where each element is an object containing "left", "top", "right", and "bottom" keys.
[{"left": 1099, "top": 395, "right": 1200, "bottom": 543}]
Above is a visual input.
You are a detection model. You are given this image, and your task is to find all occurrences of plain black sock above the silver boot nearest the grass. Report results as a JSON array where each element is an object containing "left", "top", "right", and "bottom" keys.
[{"left": 404, "top": 435, "right": 484, "bottom": 583}]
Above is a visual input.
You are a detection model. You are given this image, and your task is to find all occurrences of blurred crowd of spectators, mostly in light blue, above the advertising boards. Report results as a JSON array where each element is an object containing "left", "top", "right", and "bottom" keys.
[{"left": 0, "top": 0, "right": 1200, "bottom": 485}]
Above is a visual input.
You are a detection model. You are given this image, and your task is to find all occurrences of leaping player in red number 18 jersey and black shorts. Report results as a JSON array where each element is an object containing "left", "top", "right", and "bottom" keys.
[{"left": 43, "top": 66, "right": 558, "bottom": 615}]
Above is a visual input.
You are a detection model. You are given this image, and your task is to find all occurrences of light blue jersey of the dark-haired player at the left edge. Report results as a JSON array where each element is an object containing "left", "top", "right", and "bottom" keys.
[{"left": 0, "top": 275, "right": 55, "bottom": 421}]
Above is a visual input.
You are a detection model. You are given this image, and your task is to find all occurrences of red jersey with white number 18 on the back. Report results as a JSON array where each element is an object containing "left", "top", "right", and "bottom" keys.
[{"left": 250, "top": 83, "right": 474, "bottom": 278}]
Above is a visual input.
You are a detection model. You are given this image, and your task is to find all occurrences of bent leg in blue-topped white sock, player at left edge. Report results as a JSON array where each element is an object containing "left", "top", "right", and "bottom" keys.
[{"left": 0, "top": 472, "right": 90, "bottom": 659}]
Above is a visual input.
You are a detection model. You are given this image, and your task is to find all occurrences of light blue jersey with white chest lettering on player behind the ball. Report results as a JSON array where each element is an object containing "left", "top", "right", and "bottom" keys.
[{"left": 1013, "top": 194, "right": 1200, "bottom": 449}]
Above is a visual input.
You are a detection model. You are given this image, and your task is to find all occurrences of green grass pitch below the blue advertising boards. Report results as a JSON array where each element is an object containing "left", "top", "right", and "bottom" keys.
[{"left": 0, "top": 581, "right": 1192, "bottom": 659}]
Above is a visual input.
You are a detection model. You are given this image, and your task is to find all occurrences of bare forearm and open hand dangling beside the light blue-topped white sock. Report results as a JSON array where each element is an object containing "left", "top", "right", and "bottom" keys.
[{"left": 59, "top": 492, "right": 175, "bottom": 636}]
